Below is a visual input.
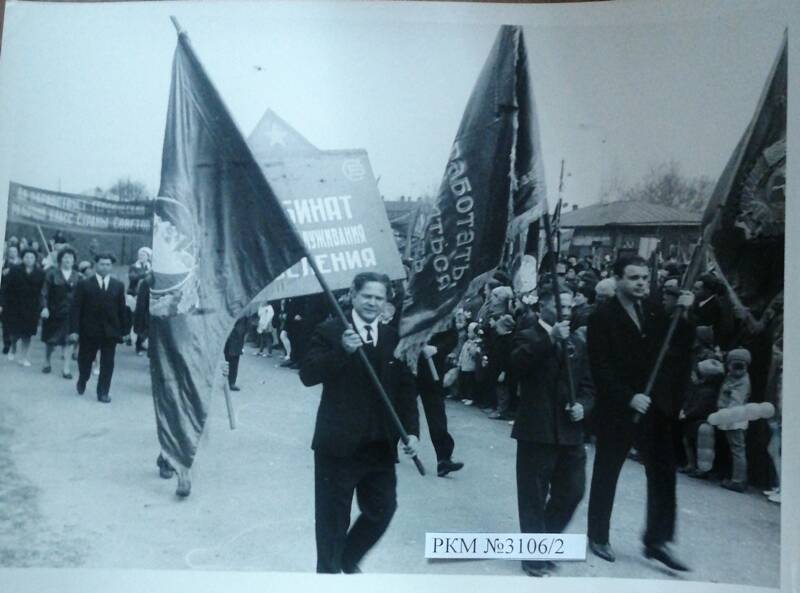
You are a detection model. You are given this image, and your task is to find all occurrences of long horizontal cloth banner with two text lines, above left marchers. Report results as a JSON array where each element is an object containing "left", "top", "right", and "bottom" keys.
[{"left": 8, "top": 181, "right": 153, "bottom": 236}]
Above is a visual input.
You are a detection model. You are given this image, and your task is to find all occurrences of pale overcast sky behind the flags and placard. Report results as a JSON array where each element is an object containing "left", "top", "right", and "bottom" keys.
[{"left": 0, "top": 1, "right": 786, "bottom": 219}]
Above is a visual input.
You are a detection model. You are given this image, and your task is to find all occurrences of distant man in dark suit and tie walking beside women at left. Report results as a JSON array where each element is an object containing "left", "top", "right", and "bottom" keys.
[{"left": 70, "top": 253, "right": 127, "bottom": 403}]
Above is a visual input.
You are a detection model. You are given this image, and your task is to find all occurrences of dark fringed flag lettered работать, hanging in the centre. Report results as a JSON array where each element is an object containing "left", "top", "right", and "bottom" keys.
[{"left": 396, "top": 25, "right": 546, "bottom": 368}]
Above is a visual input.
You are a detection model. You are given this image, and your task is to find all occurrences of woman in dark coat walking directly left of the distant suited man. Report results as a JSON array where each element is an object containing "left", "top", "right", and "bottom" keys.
[{"left": 42, "top": 247, "right": 80, "bottom": 379}]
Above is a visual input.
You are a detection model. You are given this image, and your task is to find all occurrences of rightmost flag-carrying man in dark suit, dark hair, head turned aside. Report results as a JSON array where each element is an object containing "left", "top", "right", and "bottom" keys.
[{"left": 587, "top": 256, "right": 694, "bottom": 570}]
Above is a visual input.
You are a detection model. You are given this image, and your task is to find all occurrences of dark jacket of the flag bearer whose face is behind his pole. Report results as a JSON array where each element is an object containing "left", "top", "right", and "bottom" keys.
[{"left": 511, "top": 322, "right": 594, "bottom": 445}]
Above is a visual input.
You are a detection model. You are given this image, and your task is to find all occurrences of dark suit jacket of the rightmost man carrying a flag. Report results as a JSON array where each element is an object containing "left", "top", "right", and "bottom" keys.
[{"left": 587, "top": 297, "right": 694, "bottom": 431}]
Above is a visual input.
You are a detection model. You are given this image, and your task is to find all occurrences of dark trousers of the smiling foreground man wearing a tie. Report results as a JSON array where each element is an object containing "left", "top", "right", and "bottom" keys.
[{"left": 314, "top": 451, "right": 397, "bottom": 573}]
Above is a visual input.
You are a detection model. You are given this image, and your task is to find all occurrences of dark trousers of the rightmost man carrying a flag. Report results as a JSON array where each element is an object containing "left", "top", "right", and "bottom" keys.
[{"left": 588, "top": 408, "right": 676, "bottom": 545}]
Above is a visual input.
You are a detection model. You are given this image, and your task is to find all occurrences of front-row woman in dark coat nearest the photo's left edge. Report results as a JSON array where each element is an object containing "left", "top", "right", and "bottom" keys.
[{"left": 3, "top": 249, "right": 44, "bottom": 367}]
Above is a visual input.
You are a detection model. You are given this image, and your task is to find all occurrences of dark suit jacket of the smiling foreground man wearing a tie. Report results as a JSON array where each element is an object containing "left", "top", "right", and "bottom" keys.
[{"left": 300, "top": 312, "right": 419, "bottom": 460}]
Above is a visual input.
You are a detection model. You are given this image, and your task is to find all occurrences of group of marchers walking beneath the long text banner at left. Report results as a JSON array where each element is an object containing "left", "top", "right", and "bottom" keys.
[{"left": 0, "top": 233, "right": 152, "bottom": 403}]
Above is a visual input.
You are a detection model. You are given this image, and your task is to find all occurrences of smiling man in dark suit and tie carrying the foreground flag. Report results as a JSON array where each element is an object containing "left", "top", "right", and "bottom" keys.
[{"left": 300, "top": 272, "right": 419, "bottom": 573}]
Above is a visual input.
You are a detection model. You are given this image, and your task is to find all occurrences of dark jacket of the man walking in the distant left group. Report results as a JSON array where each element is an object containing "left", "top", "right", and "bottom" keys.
[{"left": 70, "top": 276, "right": 128, "bottom": 339}]
